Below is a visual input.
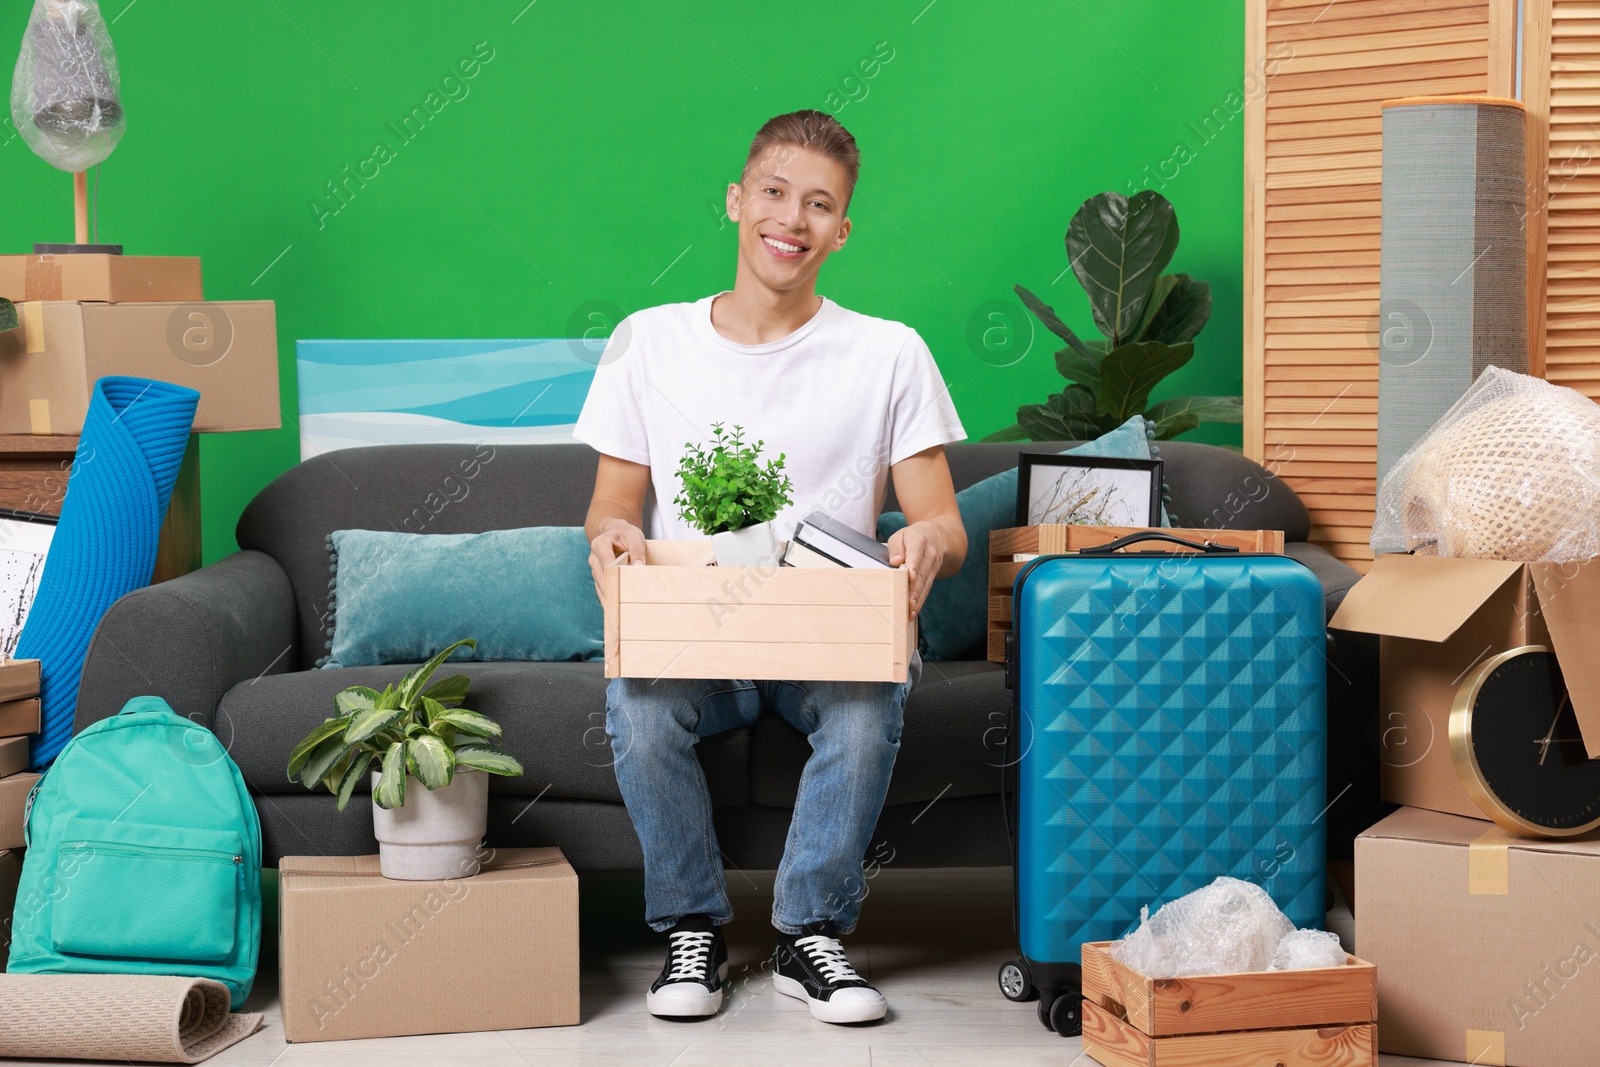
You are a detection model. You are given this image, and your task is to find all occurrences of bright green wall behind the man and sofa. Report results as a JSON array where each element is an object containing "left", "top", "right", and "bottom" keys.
[{"left": 0, "top": 0, "right": 1243, "bottom": 561}]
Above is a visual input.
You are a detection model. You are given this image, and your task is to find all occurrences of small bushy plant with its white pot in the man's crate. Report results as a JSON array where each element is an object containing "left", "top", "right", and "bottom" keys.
[{"left": 672, "top": 422, "right": 794, "bottom": 566}]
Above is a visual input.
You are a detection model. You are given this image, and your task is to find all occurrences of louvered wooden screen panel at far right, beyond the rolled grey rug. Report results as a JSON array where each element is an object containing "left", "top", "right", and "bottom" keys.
[{"left": 1523, "top": 0, "right": 1600, "bottom": 400}]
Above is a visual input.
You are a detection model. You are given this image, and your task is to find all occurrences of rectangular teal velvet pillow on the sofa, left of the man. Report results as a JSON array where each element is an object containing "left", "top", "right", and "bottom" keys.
[{"left": 317, "top": 526, "right": 605, "bottom": 667}]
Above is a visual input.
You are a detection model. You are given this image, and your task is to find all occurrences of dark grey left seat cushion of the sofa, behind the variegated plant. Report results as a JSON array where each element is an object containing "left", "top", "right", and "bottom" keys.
[{"left": 216, "top": 662, "right": 749, "bottom": 805}]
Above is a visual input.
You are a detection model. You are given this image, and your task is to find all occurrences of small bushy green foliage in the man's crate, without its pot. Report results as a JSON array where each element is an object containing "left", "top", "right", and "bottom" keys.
[{"left": 672, "top": 422, "right": 794, "bottom": 534}]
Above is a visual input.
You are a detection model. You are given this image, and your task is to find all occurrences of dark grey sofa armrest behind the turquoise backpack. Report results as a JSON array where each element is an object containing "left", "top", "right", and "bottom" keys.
[{"left": 75, "top": 550, "right": 298, "bottom": 741}]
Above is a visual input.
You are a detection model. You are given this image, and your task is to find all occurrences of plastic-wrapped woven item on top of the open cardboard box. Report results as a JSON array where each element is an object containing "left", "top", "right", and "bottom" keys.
[{"left": 1373, "top": 366, "right": 1600, "bottom": 563}]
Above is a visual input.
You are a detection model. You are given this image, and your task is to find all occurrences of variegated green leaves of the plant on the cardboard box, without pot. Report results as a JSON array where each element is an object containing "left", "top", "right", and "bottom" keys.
[{"left": 288, "top": 637, "right": 522, "bottom": 811}]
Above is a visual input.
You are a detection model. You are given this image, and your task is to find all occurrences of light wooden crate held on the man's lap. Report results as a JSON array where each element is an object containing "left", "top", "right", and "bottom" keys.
[{"left": 603, "top": 541, "right": 917, "bottom": 681}]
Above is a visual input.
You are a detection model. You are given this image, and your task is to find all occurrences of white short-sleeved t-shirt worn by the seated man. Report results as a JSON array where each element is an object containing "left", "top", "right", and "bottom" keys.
[{"left": 573, "top": 294, "right": 966, "bottom": 539}]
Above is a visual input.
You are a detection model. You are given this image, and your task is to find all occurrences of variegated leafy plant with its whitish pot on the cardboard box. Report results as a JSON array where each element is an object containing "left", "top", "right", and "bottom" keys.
[{"left": 288, "top": 638, "right": 522, "bottom": 880}]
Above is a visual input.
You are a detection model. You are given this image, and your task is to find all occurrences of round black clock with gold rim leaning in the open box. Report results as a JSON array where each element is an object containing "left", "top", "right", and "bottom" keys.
[{"left": 1450, "top": 645, "right": 1600, "bottom": 837}]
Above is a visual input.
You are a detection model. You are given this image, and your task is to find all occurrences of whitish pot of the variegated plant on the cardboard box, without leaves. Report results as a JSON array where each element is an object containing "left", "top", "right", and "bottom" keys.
[{"left": 373, "top": 768, "right": 490, "bottom": 881}]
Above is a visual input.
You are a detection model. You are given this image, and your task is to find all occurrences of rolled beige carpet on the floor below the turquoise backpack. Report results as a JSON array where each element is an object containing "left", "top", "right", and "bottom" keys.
[{"left": 0, "top": 974, "right": 261, "bottom": 1064}]
